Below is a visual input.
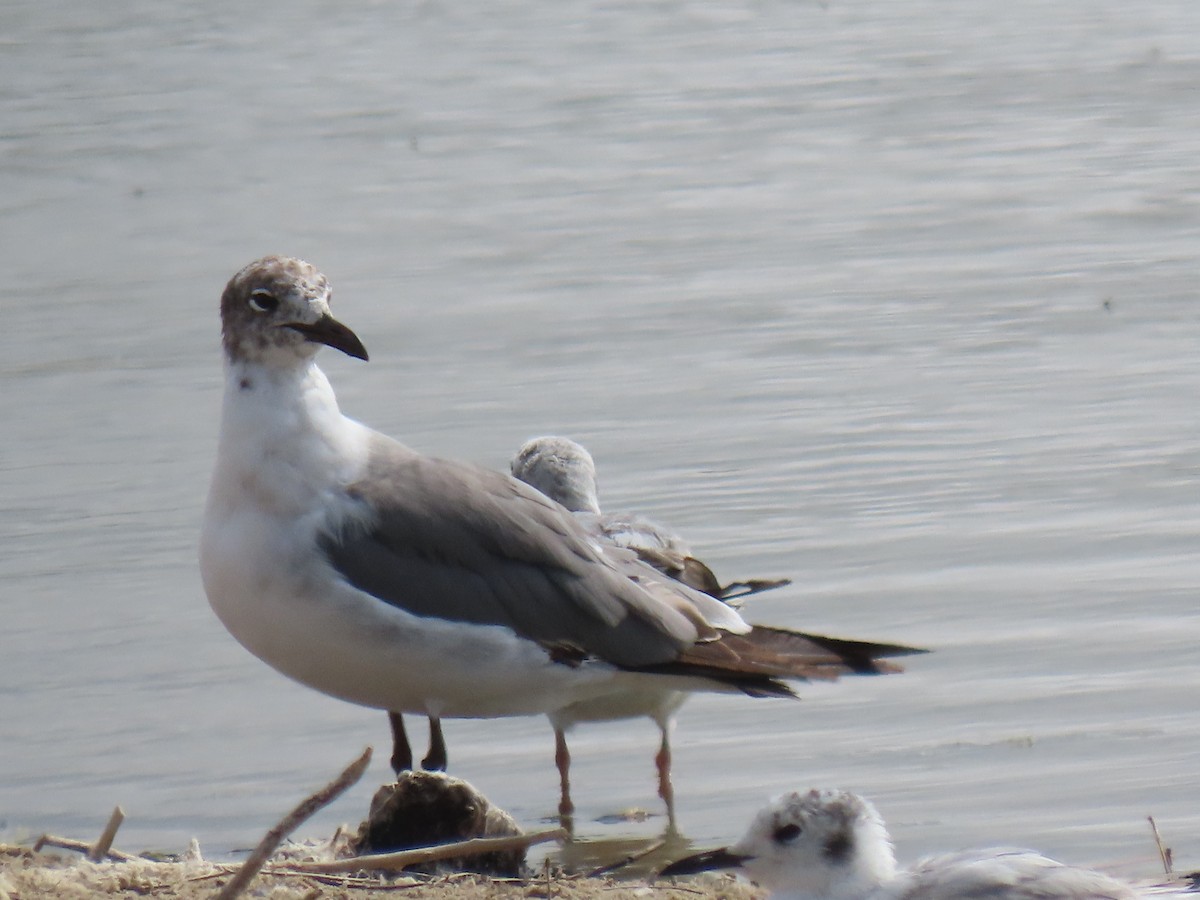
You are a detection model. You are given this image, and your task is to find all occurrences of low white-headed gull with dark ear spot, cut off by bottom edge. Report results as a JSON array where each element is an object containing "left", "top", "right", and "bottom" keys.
[{"left": 660, "top": 791, "right": 1184, "bottom": 900}]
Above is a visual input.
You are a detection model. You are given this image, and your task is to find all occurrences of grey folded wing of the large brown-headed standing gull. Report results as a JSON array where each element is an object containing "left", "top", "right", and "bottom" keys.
[{"left": 320, "top": 434, "right": 744, "bottom": 667}]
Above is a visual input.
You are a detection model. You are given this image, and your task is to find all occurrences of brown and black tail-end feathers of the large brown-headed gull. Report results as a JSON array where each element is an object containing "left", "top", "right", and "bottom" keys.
[{"left": 647, "top": 625, "right": 928, "bottom": 696}]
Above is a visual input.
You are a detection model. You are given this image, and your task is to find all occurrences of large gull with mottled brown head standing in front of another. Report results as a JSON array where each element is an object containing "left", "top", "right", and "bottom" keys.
[{"left": 200, "top": 257, "right": 913, "bottom": 820}]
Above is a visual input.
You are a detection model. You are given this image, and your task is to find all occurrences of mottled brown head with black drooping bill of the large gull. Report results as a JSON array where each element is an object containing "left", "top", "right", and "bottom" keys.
[{"left": 221, "top": 257, "right": 367, "bottom": 367}]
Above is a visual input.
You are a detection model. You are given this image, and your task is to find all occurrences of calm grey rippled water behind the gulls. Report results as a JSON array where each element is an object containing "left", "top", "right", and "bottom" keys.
[{"left": 0, "top": 0, "right": 1200, "bottom": 874}]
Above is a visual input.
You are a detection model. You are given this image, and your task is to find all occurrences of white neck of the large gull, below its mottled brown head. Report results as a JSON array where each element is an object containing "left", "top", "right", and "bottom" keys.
[{"left": 210, "top": 359, "right": 371, "bottom": 516}]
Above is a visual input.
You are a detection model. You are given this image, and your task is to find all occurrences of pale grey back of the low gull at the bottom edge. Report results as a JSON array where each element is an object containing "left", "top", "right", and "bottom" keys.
[{"left": 893, "top": 848, "right": 1136, "bottom": 900}]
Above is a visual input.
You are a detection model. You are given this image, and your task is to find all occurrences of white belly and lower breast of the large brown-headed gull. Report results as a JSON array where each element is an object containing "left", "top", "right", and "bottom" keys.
[{"left": 200, "top": 501, "right": 617, "bottom": 718}]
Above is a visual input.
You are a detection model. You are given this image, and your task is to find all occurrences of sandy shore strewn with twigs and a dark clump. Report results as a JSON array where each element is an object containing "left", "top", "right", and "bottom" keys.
[{"left": 0, "top": 763, "right": 760, "bottom": 900}]
